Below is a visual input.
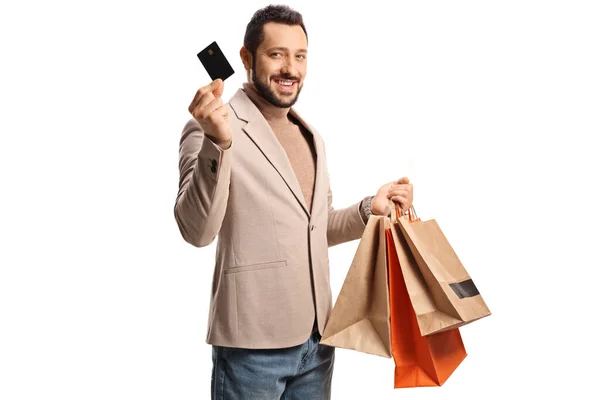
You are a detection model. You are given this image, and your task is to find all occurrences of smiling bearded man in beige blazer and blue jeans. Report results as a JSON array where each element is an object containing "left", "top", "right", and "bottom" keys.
[{"left": 175, "top": 6, "right": 413, "bottom": 400}]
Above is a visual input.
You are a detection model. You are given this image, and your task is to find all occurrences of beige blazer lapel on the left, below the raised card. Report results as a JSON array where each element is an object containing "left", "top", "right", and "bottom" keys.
[{"left": 229, "top": 89, "right": 310, "bottom": 217}]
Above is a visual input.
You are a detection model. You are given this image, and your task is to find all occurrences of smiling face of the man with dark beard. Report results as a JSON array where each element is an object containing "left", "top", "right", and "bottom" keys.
[{"left": 252, "top": 22, "right": 308, "bottom": 108}]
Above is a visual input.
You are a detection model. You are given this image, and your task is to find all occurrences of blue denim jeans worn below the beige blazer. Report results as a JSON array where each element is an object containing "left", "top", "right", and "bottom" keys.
[{"left": 211, "top": 332, "right": 335, "bottom": 400}]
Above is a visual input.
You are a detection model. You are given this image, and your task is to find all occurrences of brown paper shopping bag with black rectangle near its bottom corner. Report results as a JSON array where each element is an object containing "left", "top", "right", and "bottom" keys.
[{"left": 392, "top": 204, "right": 491, "bottom": 335}]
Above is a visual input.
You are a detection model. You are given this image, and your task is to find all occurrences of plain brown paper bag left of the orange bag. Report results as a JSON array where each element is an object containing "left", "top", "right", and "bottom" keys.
[{"left": 320, "top": 216, "right": 392, "bottom": 358}]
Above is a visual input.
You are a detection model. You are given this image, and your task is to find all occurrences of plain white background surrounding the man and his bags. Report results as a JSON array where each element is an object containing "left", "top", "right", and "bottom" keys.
[{"left": 0, "top": 0, "right": 600, "bottom": 400}]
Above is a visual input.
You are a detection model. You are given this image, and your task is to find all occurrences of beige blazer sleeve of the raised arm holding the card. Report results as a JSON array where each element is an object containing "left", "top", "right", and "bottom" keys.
[{"left": 174, "top": 119, "right": 234, "bottom": 247}]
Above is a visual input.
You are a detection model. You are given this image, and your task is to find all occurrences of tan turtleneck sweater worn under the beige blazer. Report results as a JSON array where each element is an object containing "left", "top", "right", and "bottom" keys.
[{"left": 243, "top": 83, "right": 317, "bottom": 210}]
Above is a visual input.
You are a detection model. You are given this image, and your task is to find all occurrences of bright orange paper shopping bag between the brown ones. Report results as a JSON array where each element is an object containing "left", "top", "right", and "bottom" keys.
[{"left": 386, "top": 225, "right": 467, "bottom": 388}]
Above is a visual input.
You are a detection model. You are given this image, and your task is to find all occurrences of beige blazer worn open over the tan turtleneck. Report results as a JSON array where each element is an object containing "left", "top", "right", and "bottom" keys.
[{"left": 175, "top": 89, "right": 365, "bottom": 348}]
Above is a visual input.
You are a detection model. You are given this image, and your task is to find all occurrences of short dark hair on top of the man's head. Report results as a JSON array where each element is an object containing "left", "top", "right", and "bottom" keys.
[{"left": 244, "top": 4, "right": 308, "bottom": 57}]
